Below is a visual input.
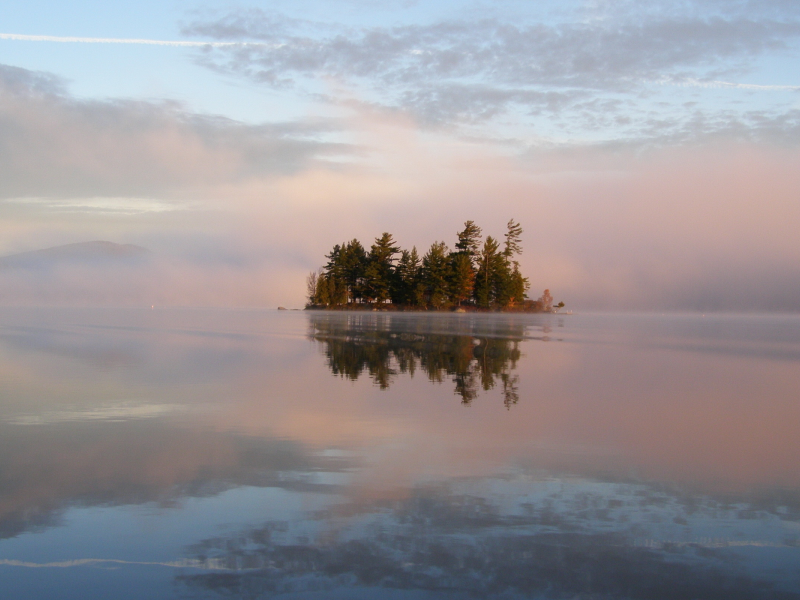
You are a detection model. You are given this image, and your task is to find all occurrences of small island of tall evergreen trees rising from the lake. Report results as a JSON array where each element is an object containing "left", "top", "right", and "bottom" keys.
[{"left": 306, "top": 219, "right": 564, "bottom": 312}]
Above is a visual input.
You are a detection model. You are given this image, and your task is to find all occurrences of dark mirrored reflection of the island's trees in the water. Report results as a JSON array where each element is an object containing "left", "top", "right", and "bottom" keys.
[{"left": 309, "top": 313, "right": 526, "bottom": 407}]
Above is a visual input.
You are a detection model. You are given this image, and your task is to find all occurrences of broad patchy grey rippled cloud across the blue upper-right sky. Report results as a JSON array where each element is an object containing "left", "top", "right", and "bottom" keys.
[{"left": 183, "top": 2, "right": 800, "bottom": 139}]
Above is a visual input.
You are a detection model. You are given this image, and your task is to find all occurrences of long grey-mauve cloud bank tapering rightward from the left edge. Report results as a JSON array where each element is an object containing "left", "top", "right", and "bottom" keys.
[{"left": 0, "top": 65, "right": 353, "bottom": 199}]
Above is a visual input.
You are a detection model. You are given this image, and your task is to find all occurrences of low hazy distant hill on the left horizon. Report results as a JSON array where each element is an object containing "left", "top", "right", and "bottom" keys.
[{"left": 0, "top": 241, "right": 151, "bottom": 269}]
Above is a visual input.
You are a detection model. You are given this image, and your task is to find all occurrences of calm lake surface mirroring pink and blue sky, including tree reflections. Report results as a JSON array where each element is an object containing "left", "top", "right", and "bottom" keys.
[{"left": 0, "top": 309, "right": 800, "bottom": 600}]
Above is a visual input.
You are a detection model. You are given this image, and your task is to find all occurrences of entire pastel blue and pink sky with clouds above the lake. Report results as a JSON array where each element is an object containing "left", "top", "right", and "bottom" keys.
[{"left": 0, "top": 0, "right": 800, "bottom": 311}]
